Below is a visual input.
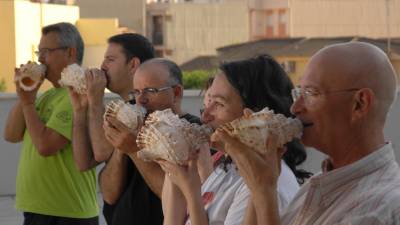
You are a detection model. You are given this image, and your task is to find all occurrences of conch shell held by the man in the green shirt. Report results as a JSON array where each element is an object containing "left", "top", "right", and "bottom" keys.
[{"left": 16, "top": 62, "right": 46, "bottom": 91}]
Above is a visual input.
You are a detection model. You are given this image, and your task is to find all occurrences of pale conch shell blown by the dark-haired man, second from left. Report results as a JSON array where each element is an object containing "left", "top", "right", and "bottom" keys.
[{"left": 58, "top": 63, "right": 86, "bottom": 94}]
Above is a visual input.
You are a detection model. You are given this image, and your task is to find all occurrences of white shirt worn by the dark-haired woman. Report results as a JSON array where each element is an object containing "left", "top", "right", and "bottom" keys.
[{"left": 186, "top": 160, "right": 299, "bottom": 225}]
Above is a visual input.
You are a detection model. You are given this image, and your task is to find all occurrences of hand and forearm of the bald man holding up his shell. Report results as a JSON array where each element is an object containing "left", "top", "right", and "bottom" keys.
[{"left": 211, "top": 127, "right": 285, "bottom": 193}]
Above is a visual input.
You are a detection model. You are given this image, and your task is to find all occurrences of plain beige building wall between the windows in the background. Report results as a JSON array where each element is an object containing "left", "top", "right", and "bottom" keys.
[{"left": 148, "top": 1, "right": 249, "bottom": 64}]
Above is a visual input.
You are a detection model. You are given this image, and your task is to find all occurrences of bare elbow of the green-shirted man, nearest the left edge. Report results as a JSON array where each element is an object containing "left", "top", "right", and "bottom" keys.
[{"left": 3, "top": 101, "right": 26, "bottom": 143}]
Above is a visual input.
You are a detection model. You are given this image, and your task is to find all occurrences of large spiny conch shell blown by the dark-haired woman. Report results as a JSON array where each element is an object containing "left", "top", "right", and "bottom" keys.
[{"left": 136, "top": 109, "right": 212, "bottom": 165}]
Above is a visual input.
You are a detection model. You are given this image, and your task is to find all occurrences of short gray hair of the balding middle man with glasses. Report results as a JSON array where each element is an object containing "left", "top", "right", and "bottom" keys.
[{"left": 140, "top": 58, "right": 183, "bottom": 85}]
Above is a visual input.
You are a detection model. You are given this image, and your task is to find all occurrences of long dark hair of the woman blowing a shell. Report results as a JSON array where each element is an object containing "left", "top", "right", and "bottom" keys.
[{"left": 220, "top": 55, "right": 311, "bottom": 183}]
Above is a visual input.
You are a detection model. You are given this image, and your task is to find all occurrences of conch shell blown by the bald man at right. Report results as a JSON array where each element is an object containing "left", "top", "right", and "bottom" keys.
[{"left": 224, "top": 108, "right": 303, "bottom": 153}]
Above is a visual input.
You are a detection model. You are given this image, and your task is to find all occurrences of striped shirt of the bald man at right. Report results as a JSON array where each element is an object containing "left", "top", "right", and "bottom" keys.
[{"left": 282, "top": 143, "right": 400, "bottom": 225}]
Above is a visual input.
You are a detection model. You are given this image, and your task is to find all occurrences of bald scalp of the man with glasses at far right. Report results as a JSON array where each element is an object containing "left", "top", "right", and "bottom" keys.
[{"left": 310, "top": 42, "right": 397, "bottom": 119}]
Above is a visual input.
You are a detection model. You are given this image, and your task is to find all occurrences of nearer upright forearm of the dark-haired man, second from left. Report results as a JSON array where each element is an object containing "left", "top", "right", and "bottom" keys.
[{"left": 89, "top": 104, "right": 114, "bottom": 162}]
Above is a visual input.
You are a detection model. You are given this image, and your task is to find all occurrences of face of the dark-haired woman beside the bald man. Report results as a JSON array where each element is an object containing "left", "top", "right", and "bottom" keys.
[{"left": 202, "top": 73, "right": 243, "bottom": 129}]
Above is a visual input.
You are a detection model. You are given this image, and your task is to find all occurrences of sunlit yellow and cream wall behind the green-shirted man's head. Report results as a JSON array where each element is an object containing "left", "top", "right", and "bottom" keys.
[{"left": 0, "top": 0, "right": 79, "bottom": 92}]
